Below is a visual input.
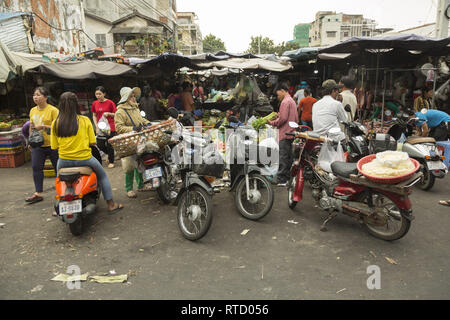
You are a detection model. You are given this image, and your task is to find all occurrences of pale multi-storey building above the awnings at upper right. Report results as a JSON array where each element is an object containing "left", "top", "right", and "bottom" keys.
[{"left": 309, "top": 11, "right": 392, "bottom": 47}]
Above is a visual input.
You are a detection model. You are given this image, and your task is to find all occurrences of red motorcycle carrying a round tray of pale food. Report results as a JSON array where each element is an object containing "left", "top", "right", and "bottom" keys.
[{"left": 288, "top": 124, "right": 421, "bottom": 241}]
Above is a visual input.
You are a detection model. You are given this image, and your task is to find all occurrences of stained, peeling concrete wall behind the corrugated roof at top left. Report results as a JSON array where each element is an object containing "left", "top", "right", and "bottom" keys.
[{"left": 0, "top": 0, "right": 85, "bottom": 53}]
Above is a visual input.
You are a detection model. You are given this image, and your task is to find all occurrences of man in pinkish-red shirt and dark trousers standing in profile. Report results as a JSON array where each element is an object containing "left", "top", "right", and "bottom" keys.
[{"left": 269, "top": 83, "right": 298, "bottom": 187}]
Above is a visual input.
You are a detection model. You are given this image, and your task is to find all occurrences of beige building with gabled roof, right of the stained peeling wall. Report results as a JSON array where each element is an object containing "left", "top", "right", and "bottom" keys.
[{"left": 84, "top": 0, "right": 177, "bottom": 56}]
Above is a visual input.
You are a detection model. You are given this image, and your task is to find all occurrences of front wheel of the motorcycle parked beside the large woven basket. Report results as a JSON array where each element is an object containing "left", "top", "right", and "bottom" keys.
[{"left": 177, "top": 186, "right": 212, "bottom": 241}]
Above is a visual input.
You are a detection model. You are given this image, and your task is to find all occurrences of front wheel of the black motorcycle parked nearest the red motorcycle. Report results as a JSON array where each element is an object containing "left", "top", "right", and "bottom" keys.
[{"left": 235, "top": 174, "right": 274, "bottom": 220}]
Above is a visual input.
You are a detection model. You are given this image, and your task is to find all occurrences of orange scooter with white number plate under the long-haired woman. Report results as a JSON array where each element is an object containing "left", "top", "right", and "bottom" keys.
[{"left": 54, "top": 146, "right": 101, "bottom": 236}]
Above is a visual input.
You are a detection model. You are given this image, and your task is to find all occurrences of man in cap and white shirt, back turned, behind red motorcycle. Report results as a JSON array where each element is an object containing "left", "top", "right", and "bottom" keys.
[{"left": 312, "top": 79, "right": 348, "bottom": 140}]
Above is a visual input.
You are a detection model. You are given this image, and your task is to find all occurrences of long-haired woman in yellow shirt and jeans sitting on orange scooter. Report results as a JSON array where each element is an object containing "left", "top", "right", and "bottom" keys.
[{"left": 51, "top": 92, "right": 123, "bottom": 213}]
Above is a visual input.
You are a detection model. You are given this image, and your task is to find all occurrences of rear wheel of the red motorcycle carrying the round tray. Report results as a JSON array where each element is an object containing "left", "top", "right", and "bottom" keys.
[{"left": 364, "top": 193, "right": 411, "bottom": 241}]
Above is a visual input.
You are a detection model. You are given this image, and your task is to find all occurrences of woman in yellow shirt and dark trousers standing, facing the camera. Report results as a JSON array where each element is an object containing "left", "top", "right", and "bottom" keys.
[{"left": 25, "top": 87, "right": 58, "bottom": 203}]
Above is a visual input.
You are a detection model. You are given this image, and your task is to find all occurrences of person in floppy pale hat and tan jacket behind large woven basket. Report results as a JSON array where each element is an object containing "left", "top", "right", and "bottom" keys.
[{"left": 114, "top": 87, "right": 150, "bottom": 198}]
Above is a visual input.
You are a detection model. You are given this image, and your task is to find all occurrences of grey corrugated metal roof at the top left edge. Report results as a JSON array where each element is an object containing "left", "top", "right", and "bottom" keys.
[{"left": 0, "top": 12, "right": 30, "bottom": 53}]
